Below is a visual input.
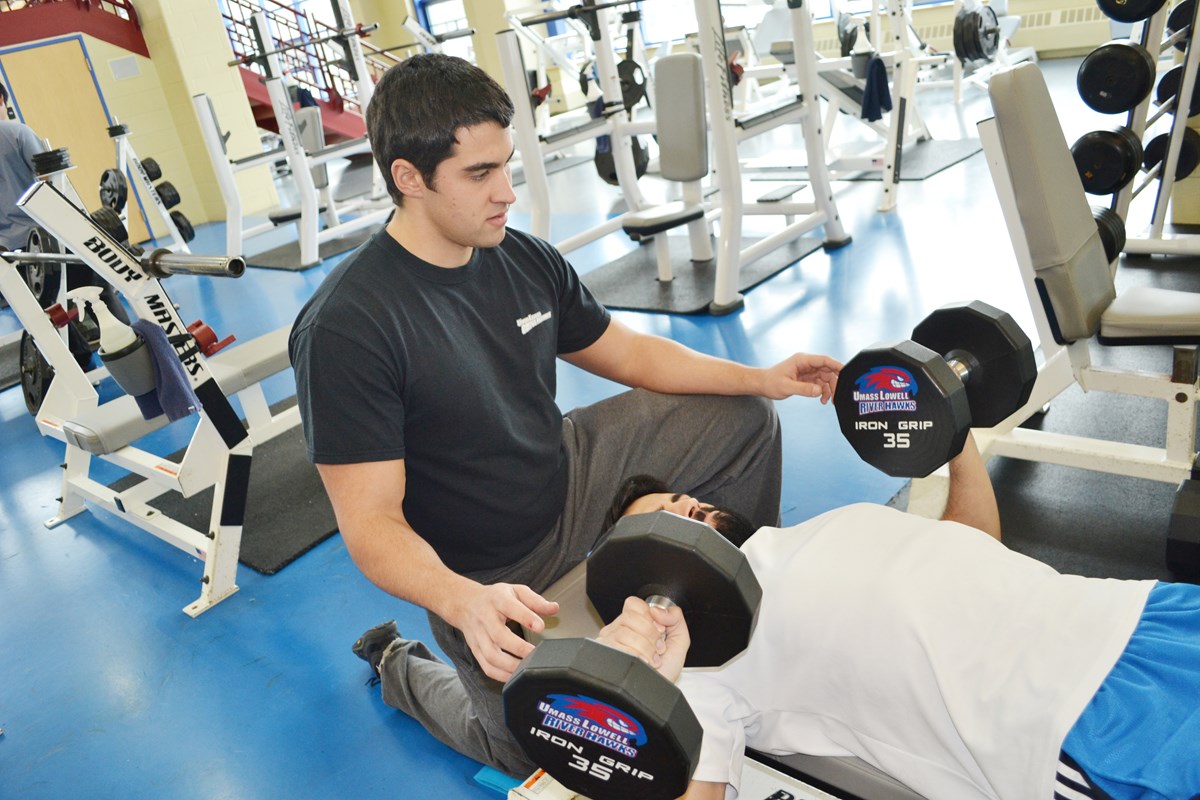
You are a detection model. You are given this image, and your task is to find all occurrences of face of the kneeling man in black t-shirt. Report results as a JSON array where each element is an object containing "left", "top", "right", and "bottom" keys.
[{"left": 422, "top": 122, "right": 516, "bottom": 261}]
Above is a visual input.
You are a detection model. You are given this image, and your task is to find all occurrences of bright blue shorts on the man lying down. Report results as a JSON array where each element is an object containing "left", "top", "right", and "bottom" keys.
[{"left": 1062, "top": 583, "right": 1200, "bottom": 800}]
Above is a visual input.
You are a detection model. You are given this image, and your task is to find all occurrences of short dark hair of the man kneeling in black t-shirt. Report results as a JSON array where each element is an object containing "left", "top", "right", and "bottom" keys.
[{"left": 367, "top": 53, "right": 514, "bottom": 205}]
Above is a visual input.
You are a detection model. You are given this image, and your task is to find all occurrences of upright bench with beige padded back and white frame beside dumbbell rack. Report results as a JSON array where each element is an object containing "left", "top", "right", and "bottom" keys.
[{"left": 910, "top": 64, "right": 1200, "bottom": 575}]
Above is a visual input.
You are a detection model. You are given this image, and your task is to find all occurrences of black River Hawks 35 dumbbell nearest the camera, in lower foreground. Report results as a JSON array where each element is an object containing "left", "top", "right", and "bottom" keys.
[{"left": 503, "top": 511, "right": 762, "bottom": 800}]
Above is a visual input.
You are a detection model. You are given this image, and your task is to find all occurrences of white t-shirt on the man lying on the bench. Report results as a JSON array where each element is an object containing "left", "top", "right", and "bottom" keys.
[{"left": 679, "top": 504, "right": 1154, "bottom": 800}]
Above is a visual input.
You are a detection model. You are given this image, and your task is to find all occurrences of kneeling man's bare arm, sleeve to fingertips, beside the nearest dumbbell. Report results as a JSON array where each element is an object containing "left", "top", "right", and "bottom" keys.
[{"left": 317, "top": 459, "right": 558, "bottom": 681}]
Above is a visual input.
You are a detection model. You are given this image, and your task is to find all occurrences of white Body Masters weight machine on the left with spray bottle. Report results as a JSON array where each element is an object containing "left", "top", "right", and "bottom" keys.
[{"left": 0, "top": 176, "right": 300, "bottom": 616}]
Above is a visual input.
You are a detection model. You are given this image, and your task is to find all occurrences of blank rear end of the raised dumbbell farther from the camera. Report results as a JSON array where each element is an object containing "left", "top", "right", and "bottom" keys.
[{"left": 912, "top": 300, "right": 1038, "bottom": 429}]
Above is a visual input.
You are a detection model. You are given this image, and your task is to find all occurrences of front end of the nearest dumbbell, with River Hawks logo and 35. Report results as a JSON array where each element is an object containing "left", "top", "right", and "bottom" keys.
[{"left": 503, "top": 639, "right": 703, "bottom": 800}]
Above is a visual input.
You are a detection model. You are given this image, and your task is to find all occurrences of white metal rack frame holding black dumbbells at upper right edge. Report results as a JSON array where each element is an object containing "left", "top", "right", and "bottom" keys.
[{"left": 1112, "top": 4, "right": 1200, "bottom": 255}]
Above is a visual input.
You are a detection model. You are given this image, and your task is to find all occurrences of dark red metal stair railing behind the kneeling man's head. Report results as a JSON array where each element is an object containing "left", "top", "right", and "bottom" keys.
[{"left": 224, "top": 0, "right": 403, "bottom": 115}]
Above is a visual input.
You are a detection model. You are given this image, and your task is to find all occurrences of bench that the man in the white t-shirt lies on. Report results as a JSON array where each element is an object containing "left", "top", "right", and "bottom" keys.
[{"left": 524, "top": 561, "right": 922, "bottom": 800}]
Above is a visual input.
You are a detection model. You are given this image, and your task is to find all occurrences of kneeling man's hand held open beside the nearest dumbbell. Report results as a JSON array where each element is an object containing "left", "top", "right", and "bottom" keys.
[{"left": 448, "top": 583, "right": 558, "bottom": 682}]
